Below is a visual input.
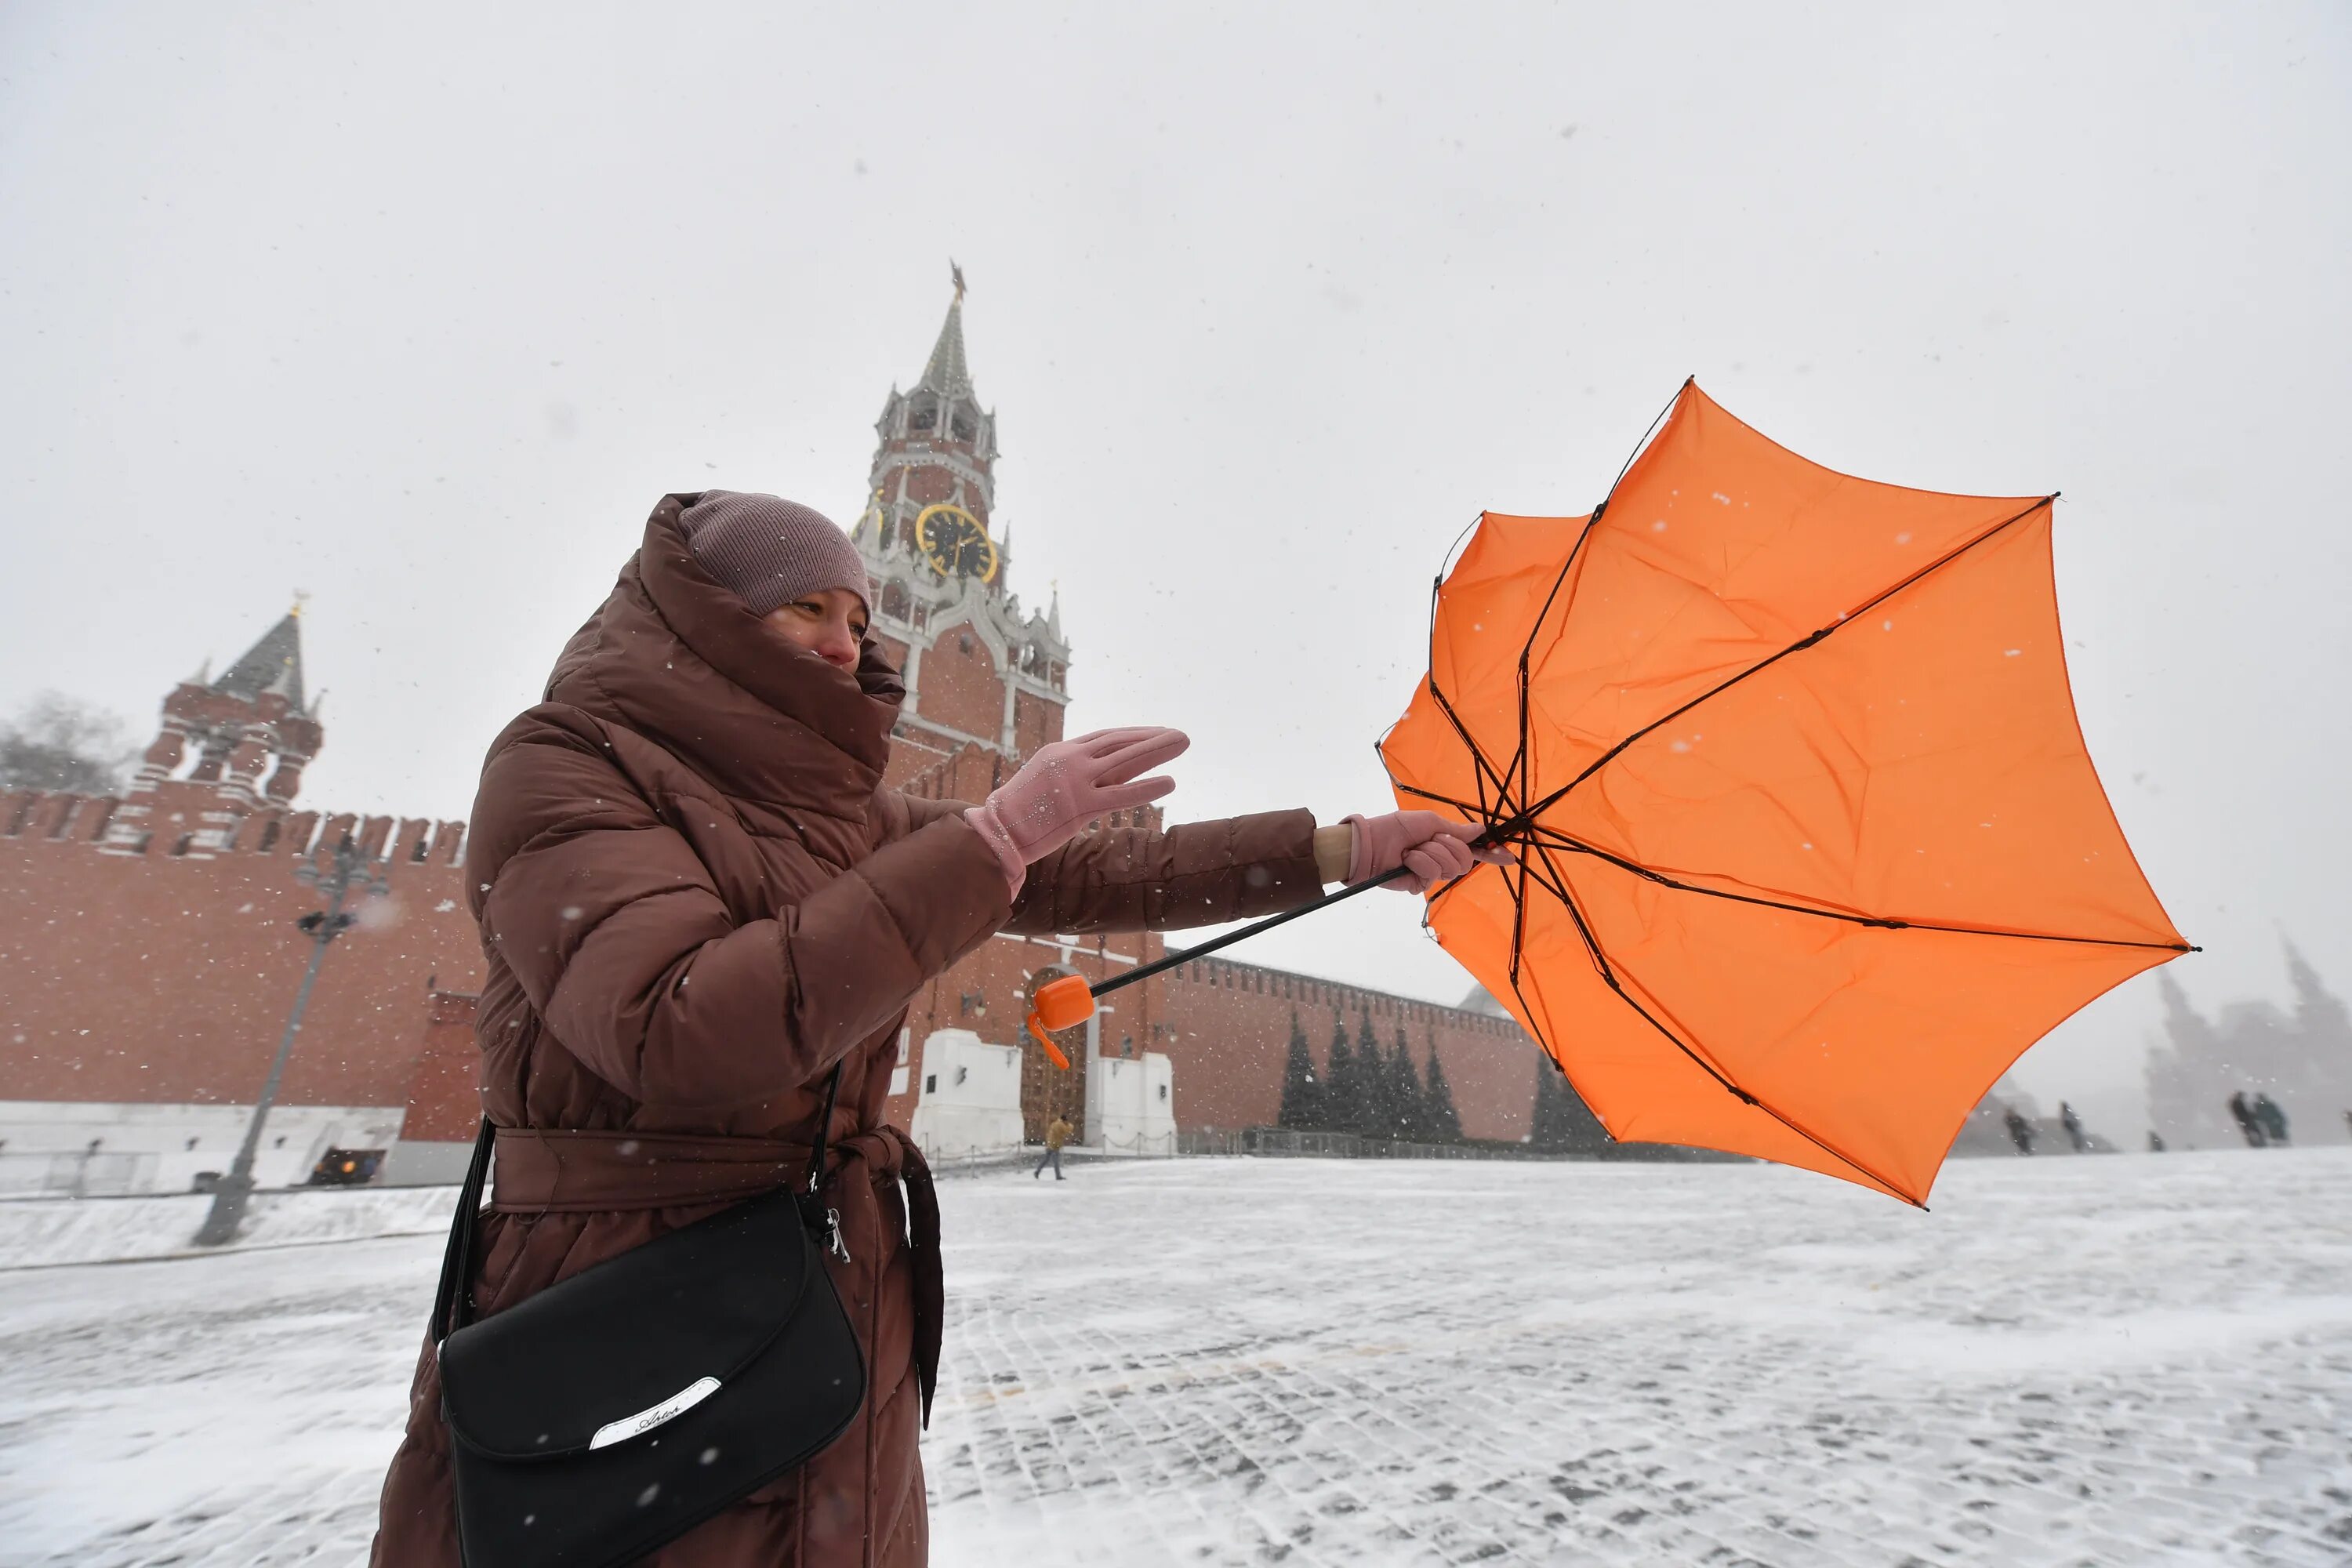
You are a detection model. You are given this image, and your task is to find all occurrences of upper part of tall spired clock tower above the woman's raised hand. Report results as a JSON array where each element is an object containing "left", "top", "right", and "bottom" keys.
[{"left": 851, "top": 268, "right": 1070, "bottom": 783}]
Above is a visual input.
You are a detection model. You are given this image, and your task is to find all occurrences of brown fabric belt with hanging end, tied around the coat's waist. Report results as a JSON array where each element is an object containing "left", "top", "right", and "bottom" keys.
[{"left": 489, "top": 1126, "right": 948, "bottom": 1425}]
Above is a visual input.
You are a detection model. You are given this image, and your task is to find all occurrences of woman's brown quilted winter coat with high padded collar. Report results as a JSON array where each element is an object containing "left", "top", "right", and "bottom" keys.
[{"left": 372, "top": 496, "right": 1319, "bottom": 1568}]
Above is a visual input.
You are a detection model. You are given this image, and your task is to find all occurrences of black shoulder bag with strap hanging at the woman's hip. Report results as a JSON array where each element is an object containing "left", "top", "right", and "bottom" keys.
[{"left": 433, "top": 1067, "right": 866, "bottom": 1568}]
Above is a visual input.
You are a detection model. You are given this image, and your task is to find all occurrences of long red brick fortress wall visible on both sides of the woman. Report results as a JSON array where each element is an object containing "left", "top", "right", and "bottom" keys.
[{"left": 0, "top": 780, "right": 1536, "bottom": 1161}]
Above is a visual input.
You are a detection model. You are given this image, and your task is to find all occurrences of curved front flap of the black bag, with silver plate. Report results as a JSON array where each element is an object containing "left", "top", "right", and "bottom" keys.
[{"left": 440, "top": 1192, "right": 823, "bottom": 1460}]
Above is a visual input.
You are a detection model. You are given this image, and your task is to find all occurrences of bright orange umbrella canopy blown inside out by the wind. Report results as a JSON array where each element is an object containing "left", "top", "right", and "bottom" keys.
[{"left": 1381, "top": 383, "right": 2190, "bottom": 1203}]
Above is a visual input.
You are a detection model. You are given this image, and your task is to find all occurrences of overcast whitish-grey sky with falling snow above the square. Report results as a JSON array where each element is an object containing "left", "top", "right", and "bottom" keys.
[{"left": 0, "top": 2, "right": 2352, "bottom": 1142}]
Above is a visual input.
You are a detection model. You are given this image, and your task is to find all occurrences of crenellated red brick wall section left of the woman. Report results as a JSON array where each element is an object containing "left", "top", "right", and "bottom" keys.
[{"left": 0, "top": 797, "right": 482, "bottom": 1105}]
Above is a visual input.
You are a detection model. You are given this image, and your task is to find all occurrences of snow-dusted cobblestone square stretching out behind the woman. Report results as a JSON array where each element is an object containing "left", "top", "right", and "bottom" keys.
[{"left": 0, "top": 1149, "right": 2352, "bottom": 1568}]
